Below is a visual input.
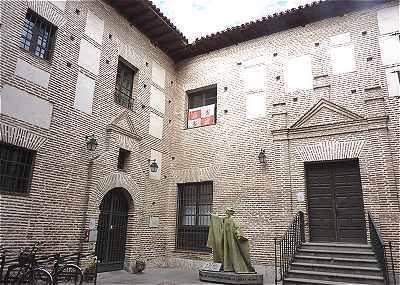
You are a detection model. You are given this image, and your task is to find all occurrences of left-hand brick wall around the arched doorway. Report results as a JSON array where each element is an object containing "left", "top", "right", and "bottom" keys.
[{"left": 0, "top": 1, "right": 175, "bottom": 266}]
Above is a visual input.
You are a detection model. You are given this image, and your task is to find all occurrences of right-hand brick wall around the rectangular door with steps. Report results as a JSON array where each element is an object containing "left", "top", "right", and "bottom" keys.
[{"left": 168, "top": 3, "right": 400, "bottom": 264}]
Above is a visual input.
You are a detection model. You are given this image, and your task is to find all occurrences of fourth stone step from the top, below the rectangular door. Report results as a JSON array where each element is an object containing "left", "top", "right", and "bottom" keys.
[{"left": 290, "top": 261, "right": 382, "bottom": 276}]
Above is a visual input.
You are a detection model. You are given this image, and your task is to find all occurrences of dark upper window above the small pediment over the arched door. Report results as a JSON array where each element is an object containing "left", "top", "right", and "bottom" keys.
[{"left": 115, "top": 58, "right": 137, "bottom": 110}]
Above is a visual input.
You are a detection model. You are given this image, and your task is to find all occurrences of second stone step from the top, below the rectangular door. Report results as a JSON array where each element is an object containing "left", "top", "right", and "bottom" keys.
[{"left": 298, "top": 247, "right": 375, "bottom": 259}]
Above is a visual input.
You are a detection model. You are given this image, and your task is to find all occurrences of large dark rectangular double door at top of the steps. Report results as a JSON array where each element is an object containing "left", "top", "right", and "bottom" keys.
[{"left": 306, "top": 160, "right": 366, "bottom": 243}]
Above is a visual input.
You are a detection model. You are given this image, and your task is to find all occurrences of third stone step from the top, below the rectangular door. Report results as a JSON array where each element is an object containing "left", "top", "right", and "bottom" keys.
[{"left": 295, "top": 254, "right": 379, "bottom": 267}]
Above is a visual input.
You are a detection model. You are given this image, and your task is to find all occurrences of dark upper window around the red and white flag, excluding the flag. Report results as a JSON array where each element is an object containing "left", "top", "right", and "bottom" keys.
[{"left": 186, "top": 84, "right": 217, "bottom": 127}]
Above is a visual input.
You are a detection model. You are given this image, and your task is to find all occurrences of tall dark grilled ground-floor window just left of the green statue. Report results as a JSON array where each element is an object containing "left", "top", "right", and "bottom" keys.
[{"left": 176, "top": 182, "right": 213, "bottom": 251}]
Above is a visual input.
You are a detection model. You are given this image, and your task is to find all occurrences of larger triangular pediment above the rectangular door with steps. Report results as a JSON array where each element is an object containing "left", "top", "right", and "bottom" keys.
[{"left": 290, "top": 99, "right": 364, "bottom": 129}]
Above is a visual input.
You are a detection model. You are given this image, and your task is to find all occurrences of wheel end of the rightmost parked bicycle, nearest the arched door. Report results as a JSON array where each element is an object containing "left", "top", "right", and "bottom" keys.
[{"left": 51, "top": 254, "right": 83, "bottom": 285}]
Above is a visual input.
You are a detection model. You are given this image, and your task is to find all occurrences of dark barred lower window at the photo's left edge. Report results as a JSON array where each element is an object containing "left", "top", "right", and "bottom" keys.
[{"left": 0, "top": 143, "right": 35, "bottom": 193}]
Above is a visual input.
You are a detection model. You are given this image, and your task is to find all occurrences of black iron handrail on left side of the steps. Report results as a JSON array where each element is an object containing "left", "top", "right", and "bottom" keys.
[{"left": 274, "top": 211, "right": 306, "bottom": 284}]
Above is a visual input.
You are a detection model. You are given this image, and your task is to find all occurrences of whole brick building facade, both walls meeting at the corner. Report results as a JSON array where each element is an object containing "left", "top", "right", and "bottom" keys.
[{"left": 0, "top": 1, "right": 400, "bottom": 278}]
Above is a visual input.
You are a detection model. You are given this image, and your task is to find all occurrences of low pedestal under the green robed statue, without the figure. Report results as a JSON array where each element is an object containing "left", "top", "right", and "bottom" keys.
[{"left": 199, "top": 270, "right": 263, "bottom": 285}]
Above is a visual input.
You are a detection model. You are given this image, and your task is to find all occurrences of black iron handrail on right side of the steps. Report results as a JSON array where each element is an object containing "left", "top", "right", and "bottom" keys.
[{"left": 368, "top": 212, "right": 397, "bottom": 285}]
